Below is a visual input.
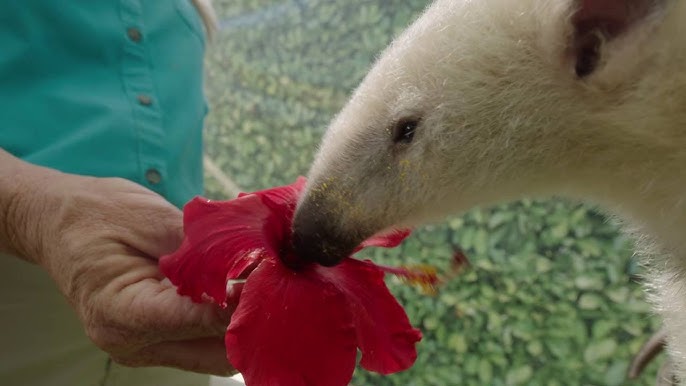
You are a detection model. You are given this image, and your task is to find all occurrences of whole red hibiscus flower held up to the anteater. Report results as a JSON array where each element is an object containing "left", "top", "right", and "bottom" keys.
[{"left": 160, "top": 178, "right": 435, "bottom": 386}]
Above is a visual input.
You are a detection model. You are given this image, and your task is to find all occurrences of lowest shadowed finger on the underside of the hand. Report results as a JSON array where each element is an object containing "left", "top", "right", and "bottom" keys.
[{"left": 112, "top": 338, "right": 236, "bottom": 376}]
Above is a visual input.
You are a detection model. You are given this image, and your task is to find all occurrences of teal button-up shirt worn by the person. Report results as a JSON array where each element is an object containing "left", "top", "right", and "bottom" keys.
[{"left": 0, "top": 0, "right": 207, "bottom": 206}]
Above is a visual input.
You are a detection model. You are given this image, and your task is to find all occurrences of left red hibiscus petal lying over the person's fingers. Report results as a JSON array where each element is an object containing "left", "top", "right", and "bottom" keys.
[{"left": 160, "top": 195, "right": 279, "bottom": 307}]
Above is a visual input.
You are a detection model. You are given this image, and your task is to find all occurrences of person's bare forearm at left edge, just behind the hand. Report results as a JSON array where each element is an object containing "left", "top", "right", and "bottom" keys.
[{"left": 0, "top": 148, "right": 59, "bottom": 263}]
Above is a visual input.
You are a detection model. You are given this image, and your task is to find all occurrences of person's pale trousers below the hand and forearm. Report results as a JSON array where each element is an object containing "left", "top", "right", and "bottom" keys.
[{"left": 0, "top": 255, "right": 209, "bottom": 386}]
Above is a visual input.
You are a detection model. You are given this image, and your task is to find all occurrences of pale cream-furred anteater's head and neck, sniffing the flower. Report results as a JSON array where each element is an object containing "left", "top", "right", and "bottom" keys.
[{"left": 294, "top": 0, "right": 686, "bottom": 378}]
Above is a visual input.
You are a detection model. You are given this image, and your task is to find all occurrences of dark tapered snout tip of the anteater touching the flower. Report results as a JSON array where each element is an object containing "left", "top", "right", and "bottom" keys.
[{"left": 293, "top": 203, "right": 357, "bottom": 267}]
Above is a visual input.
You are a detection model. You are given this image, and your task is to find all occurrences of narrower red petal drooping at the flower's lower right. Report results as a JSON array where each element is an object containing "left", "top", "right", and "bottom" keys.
[{"left": 315, "top": 259, "right": 422, "bottom": 374}]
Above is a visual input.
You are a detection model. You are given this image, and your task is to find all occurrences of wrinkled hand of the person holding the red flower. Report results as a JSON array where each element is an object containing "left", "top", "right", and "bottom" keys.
[{"left": 14, "top": 173, "right": 234, "bottom": 375}]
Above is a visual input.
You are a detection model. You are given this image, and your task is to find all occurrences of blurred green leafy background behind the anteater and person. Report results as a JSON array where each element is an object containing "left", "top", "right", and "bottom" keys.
[{"left": 206, "top": 0, "right": 662, "bottom": 386}]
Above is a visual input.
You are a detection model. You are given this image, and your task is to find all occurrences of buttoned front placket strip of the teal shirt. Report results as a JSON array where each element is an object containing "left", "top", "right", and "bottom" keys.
[{"left": 120, "top": 0, "right": 167, "bottom": 195}]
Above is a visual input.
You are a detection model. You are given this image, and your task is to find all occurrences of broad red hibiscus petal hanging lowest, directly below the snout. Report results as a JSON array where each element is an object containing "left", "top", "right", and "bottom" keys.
[{"left": 226, "top": 258, "right": 357, "bottom": 386}]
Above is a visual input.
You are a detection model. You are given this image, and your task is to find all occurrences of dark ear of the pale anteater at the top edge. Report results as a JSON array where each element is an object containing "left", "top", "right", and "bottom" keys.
[{"left": 572, "top": 0, "right": 664, "bottom": 78}]
